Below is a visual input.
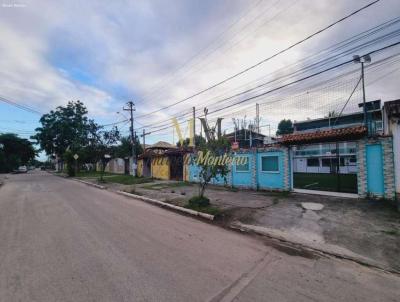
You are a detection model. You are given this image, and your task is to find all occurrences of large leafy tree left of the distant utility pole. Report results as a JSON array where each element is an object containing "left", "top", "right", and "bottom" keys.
[{"left": 32, "top": 101, "right": 98, "bottom": 168}]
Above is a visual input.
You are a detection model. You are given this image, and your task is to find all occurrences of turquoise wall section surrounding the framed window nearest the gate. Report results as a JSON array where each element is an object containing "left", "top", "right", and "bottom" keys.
[{"left": 256, "top": 151, "right": 285, "bottom": 190}]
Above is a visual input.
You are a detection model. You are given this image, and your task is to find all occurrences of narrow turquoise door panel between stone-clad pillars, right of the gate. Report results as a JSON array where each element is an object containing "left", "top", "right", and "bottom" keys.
[{"left": 366, "top": 145, "right": 384, "bottom": 195}]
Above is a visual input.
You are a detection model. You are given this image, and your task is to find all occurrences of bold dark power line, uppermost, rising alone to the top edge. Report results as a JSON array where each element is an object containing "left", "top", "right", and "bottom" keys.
[{"left": 137, "top": 0, "right": 381, "bottom": 118}]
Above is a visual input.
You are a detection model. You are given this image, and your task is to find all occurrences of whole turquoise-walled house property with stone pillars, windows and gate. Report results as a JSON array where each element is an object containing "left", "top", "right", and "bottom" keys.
[{"left": 188, "top": 100, "right": 399, "bottom": 199}]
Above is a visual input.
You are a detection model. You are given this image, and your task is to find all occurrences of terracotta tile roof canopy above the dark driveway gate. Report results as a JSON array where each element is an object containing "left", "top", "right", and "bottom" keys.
[{"left": 279, "top": 126, "right": 367, "bottom": 144}]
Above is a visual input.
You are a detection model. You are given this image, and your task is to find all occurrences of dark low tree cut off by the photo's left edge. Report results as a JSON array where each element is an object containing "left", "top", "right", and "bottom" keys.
[{"left": 0, "top": 133, "right": 36, "bottom": 173}]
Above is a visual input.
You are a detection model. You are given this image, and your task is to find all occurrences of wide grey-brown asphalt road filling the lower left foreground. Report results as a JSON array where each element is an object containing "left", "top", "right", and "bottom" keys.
[{"left": 0, "top": 172, "right": 400, "bottom": 302}]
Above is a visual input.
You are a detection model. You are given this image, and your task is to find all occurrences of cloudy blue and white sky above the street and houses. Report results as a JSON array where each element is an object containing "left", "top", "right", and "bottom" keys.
[{"left": 0, "top": 0, "right": 400, "bottom": 151}]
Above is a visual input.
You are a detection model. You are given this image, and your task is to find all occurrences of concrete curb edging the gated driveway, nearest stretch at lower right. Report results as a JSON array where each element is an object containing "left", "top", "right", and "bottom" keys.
[{"left": 230, "top": 223, "right": 400, "bottom": 275}]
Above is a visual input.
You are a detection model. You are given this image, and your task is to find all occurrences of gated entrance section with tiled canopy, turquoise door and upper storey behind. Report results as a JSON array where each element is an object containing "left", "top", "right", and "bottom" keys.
[{"left": 281, "top": 100, "right": 395, "bottom": 199}]
